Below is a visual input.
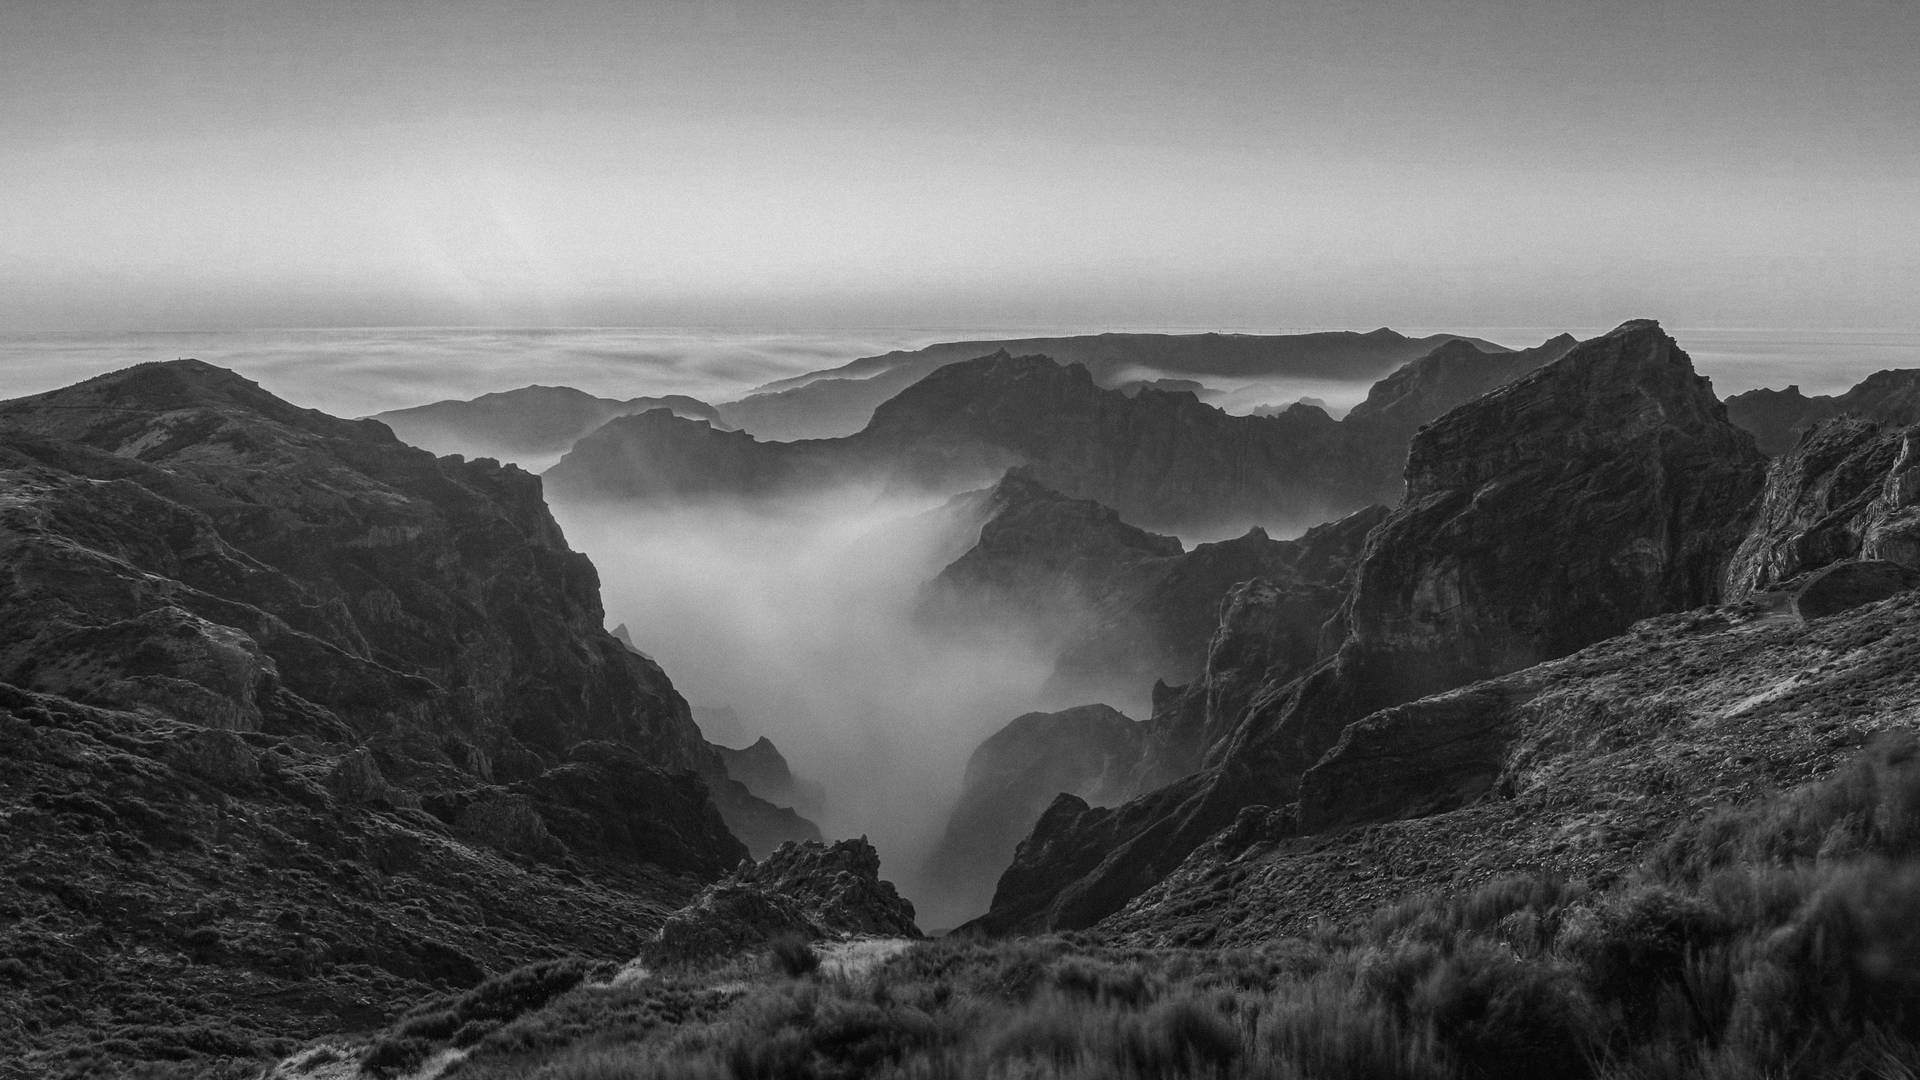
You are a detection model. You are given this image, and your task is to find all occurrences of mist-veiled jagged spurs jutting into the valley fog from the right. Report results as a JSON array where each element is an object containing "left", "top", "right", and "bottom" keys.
[{"left": 920, "top": 480, "right": 1386, "bottom": 915}]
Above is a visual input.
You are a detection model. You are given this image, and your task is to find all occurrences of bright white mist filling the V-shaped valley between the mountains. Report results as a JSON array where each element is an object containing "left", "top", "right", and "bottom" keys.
[{"left": 553, "top": 478, "right": 1113, "bottom": 926}]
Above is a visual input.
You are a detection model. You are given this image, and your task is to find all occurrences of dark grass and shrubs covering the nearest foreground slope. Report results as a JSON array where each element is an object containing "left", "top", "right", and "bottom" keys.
[{"left": 337, "top": 734, "right": 1920, "bottom": 1080}]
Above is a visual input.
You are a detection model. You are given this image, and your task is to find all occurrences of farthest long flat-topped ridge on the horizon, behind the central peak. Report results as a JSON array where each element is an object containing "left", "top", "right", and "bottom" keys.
[{"left": 720, "top": 327, "right": 1505, "bottom": 442}]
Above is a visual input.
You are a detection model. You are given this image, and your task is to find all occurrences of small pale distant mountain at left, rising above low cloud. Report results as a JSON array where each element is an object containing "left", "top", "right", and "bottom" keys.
[{"left": 371, "top": 386, "right": 726, "bottom": 471}]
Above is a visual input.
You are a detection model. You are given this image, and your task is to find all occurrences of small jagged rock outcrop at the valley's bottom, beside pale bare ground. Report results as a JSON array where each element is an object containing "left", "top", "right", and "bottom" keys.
[{"left": 641, "top": 836, "right": 920, "bottom": 963}]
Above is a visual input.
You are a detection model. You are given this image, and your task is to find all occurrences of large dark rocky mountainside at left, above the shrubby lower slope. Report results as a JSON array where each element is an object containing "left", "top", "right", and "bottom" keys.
[{"left": 0, "top": 361, "right": 712, "bottom": 778}]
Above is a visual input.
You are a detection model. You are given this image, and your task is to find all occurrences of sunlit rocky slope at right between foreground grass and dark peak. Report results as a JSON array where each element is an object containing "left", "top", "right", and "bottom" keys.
[{"left": 1094, "top": 580, "right": 1920, "bottom": 947}]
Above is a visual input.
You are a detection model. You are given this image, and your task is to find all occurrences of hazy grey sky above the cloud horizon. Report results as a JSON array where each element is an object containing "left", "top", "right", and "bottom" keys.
[{"left": 0, "top": 0, "right": 1920, "bottom": 331}]
